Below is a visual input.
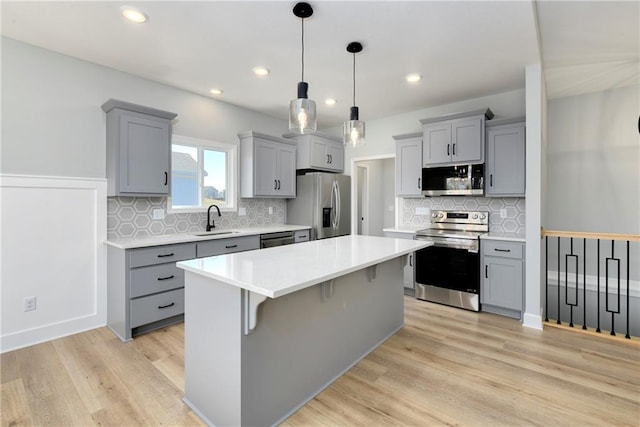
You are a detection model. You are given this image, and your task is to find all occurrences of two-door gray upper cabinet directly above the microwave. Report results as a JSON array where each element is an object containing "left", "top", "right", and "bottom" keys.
[{"left": 420, "top": 108, "right": 493, "bottom": 167}]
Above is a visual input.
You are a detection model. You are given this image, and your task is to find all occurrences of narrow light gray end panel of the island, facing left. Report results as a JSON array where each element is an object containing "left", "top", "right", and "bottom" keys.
[{"left": 184, "top": 271, "right": 242, "bottom": 426}]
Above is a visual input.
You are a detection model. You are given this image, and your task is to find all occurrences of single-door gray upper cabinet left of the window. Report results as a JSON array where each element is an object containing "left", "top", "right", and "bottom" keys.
[{"left": 102, "top": 99, "right": 177, "bottom": 196}]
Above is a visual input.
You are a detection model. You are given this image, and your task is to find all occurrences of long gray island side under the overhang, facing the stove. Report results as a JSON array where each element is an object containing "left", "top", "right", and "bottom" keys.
[{"left": 242, "top": 257, "right": 406, "bottom": 426}]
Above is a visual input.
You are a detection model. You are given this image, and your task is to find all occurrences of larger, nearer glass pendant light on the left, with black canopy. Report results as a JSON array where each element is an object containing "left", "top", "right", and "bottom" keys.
[{"left": 289, "top": 2, "right": 317, "bottom": 134}]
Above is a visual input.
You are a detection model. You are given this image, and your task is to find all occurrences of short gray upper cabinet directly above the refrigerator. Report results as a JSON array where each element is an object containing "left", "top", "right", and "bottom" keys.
[{"left": 283, "top": 132, "right": 344, "bottom": 173}]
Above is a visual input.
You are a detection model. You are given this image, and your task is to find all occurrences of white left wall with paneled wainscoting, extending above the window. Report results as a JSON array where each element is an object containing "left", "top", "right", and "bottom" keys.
[{"left": 0, "top": 38, "right": 288, "bottom": 351}]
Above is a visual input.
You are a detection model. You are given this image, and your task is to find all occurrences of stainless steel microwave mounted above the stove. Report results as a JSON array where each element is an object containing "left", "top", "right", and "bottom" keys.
[{"left": 422, "top": 163, "right": 484, "bottom": 196}]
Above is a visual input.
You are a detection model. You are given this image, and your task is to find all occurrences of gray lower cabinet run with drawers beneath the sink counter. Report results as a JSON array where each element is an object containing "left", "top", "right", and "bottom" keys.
[{"left": 107, "top": 235, "right": 260, "bottom": 341}]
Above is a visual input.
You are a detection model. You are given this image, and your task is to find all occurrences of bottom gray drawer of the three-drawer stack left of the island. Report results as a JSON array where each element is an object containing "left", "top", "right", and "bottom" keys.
[{"left": 130, "top": 288, "right": 184, "bottom": 328}]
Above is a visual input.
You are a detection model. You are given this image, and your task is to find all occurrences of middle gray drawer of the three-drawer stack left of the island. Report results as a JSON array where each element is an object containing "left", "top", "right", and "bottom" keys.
[{"left": 129, "top": 262, "right": 184, "bottom": 298}]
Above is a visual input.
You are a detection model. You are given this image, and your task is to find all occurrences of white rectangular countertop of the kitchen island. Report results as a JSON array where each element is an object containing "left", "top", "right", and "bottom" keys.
[{"left": 177, "top": 236, "right": 431, "bottom": 298}]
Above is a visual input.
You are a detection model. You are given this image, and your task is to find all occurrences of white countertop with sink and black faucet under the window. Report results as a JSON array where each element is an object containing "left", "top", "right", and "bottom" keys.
[{"left": 105, "top": 224, "right": 310, "bottom": 249}]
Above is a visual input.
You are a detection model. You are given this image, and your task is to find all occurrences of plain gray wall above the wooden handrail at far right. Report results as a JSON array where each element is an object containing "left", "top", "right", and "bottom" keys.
[{"left": 544, "top": 86, "right": 640, "bottom": 234}]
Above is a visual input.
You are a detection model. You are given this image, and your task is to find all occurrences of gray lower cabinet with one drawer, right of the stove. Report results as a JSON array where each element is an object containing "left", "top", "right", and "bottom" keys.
[{"left": 480, "top": 239, "right": 525, "bottom": 319}]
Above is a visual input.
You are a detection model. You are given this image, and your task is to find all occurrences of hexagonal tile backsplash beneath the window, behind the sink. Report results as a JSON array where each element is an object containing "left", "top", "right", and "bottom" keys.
[{"left": 107, "top": 197, "right": 287, "bottom": 239}]
